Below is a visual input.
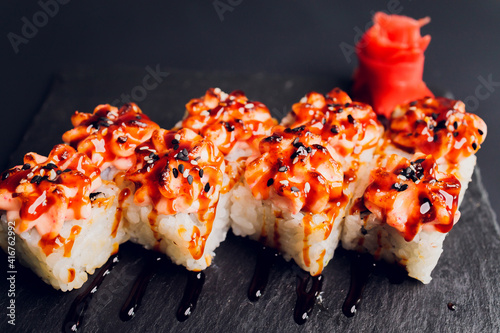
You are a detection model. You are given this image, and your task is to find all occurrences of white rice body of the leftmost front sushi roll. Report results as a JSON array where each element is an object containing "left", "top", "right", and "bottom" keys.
[{"left": 0, "top": 182, "right": 128, "bottom": 291}]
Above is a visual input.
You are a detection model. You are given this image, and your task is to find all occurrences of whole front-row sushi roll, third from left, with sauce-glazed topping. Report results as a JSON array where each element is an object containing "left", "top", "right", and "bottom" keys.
[{"left": 231, "top": 126, "right": 348, "bottom": 276}]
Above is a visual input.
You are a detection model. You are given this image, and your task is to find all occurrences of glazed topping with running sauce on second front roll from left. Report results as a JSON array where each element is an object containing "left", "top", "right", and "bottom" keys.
[{"left": 126, "top": 129, "right": 224, "bottom": 259}]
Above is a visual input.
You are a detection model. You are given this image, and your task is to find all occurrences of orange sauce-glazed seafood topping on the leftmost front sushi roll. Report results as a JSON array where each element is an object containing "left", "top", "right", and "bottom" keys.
[{"left": 0, "top": 144, "right": 101, "bottom": 239}]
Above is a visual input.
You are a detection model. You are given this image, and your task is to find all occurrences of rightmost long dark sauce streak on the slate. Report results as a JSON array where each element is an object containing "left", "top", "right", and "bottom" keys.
[{"left": 342, "top": 254, "right": 374, "bottom": 317}]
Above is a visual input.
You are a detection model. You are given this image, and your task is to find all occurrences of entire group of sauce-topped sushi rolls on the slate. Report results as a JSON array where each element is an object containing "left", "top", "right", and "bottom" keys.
[{"left": 0, "top": 88, "right": 486, "bottom": 291}]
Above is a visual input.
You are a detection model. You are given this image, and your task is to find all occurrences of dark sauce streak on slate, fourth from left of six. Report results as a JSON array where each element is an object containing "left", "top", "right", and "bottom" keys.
[{"left": 248, "top": 246, "right": 276, "bottom": 302}]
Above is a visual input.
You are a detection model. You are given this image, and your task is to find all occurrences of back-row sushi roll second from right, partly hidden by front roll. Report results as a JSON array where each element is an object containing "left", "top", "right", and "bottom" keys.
[{"left": 282, "top": 88, "right": 384, "bottom": 210}]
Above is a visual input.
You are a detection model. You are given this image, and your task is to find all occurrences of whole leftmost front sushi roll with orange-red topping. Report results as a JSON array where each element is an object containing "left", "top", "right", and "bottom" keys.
[{"left": 0, "top": 145, "right": 127, "bottom": 291}]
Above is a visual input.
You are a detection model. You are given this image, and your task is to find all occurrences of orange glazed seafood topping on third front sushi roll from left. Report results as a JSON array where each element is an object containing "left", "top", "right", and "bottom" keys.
[{"left": 245, "top": 126, "right": 344, "bottom": 214}]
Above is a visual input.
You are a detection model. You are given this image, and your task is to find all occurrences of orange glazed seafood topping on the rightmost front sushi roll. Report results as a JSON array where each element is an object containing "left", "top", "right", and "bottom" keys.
[{"left": 363, "top": 153, "right": 461, "bottom": 241}]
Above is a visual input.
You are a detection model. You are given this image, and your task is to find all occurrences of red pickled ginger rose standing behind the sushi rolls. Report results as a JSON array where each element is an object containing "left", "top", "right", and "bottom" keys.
[{"left": 353, "top": 12, "right": 434, "bottom": 117}]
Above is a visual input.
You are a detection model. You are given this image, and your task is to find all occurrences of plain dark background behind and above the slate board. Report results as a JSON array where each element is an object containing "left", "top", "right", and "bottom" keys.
[{"left": 0, "top": 0, "right": 500, "bottom": 212}]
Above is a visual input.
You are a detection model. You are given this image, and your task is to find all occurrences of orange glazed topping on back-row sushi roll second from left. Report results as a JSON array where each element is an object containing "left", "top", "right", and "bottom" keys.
[{"left": 181, "top": 88, "right": 277, "bottom": 155}]
